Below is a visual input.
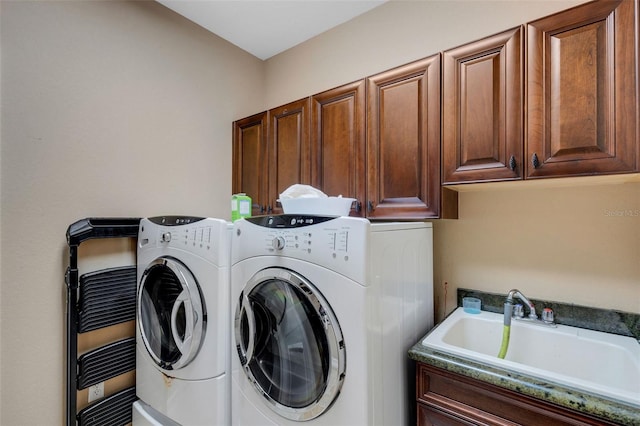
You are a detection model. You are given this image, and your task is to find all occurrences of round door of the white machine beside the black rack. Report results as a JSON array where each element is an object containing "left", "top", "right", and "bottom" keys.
[{"left": 138, "top": 257, "right": 207, "bottom": 370}]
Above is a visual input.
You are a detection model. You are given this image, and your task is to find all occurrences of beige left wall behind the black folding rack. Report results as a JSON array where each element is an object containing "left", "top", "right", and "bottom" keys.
[{"left": 0, "top": 1, "right": 264, "bottom": 426}]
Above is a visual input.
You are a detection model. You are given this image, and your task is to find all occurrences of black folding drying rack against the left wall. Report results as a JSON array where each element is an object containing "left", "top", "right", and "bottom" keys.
[{"left": 65, "top": 218, "right": 140, "bottom": 426}]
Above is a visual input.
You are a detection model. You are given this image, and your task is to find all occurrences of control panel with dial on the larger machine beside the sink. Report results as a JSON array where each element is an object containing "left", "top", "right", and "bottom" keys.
[{"left": 231, "top": 215, "right": 371, "bottom": 282}]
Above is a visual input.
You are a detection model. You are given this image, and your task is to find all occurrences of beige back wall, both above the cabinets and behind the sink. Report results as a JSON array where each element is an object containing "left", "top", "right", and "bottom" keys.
[{"left": 266, "top": 0, "right": 640, "bottom": 319}]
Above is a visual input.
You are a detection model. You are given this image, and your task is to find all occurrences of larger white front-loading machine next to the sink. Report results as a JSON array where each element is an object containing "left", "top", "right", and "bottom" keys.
[{"left": 231, "top": 215, "right": 433, "bottom": 426}]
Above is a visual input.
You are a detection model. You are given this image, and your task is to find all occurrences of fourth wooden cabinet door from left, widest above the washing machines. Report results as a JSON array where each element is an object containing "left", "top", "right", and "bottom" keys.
[{"left": 366, "top": 54, "right": 440, "bottom": 219}]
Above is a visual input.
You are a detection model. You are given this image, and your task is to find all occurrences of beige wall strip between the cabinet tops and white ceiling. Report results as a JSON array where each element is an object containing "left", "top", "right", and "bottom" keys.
[{"left": 266, "top": 0, "right": 585, "bottom": 108}]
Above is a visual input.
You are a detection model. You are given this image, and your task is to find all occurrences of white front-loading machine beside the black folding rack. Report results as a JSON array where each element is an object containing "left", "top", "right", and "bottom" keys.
[{"left": 133, "top": 216, "right": 233, "bottom": 426}]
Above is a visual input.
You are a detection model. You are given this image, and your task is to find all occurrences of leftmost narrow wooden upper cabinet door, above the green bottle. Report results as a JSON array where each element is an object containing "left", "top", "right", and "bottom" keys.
[{"left": 232, "top": 112, "right": 268, "bottom": 216}]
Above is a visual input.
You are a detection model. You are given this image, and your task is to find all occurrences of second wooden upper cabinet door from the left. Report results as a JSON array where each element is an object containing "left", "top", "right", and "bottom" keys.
[{"left": 267, "top": 98, "right": 311, "bottom": 214}]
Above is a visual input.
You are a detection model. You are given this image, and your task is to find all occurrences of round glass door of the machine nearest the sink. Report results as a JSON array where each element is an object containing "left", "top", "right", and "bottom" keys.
[{"left": 235, "top": 268, "right": 346, "bottom": 420}]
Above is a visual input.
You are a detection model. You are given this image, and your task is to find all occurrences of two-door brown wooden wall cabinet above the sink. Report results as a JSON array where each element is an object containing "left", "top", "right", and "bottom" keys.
[{"left": 442, "top": 0, "right": 640, "bottom": 184}]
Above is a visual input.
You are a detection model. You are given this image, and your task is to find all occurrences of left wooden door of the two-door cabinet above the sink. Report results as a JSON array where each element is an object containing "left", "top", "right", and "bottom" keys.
[{"left": 442, "top": 27, "right": 523, "bottom": 184}]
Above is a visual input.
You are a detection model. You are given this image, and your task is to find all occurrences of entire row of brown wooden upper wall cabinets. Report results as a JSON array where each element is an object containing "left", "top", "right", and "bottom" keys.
[{"left": 233, "top": 0, "right": 640, "bottom": 216}]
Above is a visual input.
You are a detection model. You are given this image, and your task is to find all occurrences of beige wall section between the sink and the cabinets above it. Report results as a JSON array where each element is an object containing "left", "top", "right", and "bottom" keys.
[{"left": 434, "top": 174, "right": 640, "bottom": 318}]
